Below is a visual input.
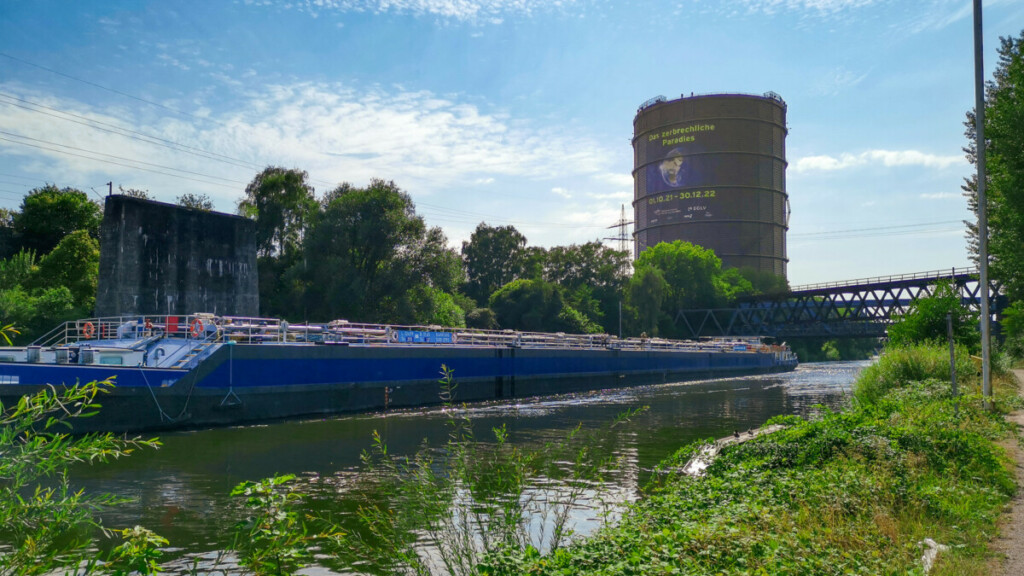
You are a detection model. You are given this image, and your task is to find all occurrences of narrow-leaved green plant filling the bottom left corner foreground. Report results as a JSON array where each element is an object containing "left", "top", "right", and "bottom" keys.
[{"left": 0, "top": 380, "right": 160, "bottom": 576}]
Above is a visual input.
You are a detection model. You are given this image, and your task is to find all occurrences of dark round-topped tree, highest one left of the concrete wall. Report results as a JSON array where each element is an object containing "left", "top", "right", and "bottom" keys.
[{"left": 13, "top": 184, "right": 102, "bottom": 254}]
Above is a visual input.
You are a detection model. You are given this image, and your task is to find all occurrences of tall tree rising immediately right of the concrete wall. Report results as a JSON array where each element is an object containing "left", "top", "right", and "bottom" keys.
[{"left": 238, "top": 166, "right": 316, "bottom": 256}]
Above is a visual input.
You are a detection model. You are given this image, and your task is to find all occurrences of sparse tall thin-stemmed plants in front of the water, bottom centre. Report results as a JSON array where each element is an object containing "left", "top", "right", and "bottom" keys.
[{"left": 339, "top": 367, "right": 638, "bottom": 575}]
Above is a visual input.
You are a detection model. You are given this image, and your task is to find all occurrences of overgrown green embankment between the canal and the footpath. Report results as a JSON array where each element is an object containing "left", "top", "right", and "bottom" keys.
[{"left": 480, "top": 346, "right": 1019, "bottom": 575}]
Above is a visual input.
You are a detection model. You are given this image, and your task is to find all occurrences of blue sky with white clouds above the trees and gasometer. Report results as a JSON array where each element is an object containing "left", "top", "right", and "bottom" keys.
[{"left": 0, "top": 0, "right": 1024, "bottom": 286}]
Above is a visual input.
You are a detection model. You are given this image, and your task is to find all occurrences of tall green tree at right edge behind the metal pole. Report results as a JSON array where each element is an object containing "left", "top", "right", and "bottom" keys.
[{"left": 964, "top": 32, "right": 1024, "bottom": 300}]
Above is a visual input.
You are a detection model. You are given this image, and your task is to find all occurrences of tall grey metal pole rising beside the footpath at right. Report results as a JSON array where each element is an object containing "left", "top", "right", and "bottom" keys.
[{"left": 974, "top": 0, "right": 992, "bottom": 409}]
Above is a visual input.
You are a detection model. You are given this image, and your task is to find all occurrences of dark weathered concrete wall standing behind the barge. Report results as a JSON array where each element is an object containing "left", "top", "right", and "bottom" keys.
[{"left": 96, "top": 196, "right": 259, "bottom": 317}]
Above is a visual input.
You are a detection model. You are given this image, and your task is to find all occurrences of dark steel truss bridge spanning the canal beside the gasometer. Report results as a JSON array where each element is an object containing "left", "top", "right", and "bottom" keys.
[{"left": 675, "top": 269, "right": 1006, "bottom": 338}]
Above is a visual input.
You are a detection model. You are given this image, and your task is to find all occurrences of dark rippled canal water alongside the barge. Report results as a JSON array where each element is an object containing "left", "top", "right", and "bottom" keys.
[{"left": 74, "top": 362, "right": 867, "bottom": 574}]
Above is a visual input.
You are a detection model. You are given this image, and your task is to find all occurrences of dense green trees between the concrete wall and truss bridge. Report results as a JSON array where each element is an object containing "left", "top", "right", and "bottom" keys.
[{"left": 232, "top": 167, "right": 785, "bottom": 336}]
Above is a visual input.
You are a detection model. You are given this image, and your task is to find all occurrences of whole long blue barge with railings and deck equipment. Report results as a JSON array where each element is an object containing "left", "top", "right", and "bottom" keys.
[{"left": 0, "top": 314, "right": 797, "bottom": 431}]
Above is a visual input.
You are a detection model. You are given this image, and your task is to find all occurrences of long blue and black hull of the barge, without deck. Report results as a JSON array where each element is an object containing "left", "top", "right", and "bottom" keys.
[{"left": 0, "top": 338, "right": 796, "bottom": 431}]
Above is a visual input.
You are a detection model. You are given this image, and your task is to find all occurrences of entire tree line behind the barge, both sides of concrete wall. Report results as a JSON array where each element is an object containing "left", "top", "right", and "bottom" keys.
[{"left": 0, "top": 166, "right": 786, "bottom": 340}]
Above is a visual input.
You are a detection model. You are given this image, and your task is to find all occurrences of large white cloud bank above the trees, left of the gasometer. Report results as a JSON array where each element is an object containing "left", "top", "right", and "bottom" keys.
[{"left": 0, "top": 83, "right": 615, "bottom": 206}]
